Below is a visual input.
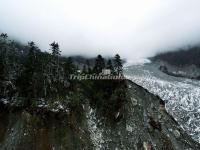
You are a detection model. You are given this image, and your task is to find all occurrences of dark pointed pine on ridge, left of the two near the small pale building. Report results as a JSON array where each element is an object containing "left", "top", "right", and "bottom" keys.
[{"left": 93, "top": 55, "right": 105, "bottom": 73}]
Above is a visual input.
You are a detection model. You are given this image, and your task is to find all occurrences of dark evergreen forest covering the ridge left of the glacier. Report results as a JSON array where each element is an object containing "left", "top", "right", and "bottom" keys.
[{"left": 0, "top": 33, "right": 126, "bottom": 120}]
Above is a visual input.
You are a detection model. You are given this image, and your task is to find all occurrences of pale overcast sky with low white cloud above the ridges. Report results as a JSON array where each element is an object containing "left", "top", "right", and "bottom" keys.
[{"left": 0, "top": 0, "right": 200, "bottom": 60}]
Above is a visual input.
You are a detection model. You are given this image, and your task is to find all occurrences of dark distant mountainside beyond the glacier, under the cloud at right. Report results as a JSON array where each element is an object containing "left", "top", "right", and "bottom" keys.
[{"left": 151, "top": 46, "right": 200, "bottom": 79}]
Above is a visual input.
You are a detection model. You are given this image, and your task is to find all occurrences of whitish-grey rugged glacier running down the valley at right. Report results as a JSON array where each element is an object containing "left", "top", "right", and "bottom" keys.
[{"left": 124, "top": 63, "right": 200, "bottom": 143}]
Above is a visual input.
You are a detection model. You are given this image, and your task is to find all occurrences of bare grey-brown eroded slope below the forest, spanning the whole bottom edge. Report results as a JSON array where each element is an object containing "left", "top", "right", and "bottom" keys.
[{"left": 0, "top": 81, "right": 200, "bottom": 150}]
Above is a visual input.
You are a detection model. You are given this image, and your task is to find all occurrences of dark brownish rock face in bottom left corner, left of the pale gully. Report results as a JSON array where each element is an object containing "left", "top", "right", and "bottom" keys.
[{"left": 0, "top": 111, "right": 92, "bottom": 150}]
